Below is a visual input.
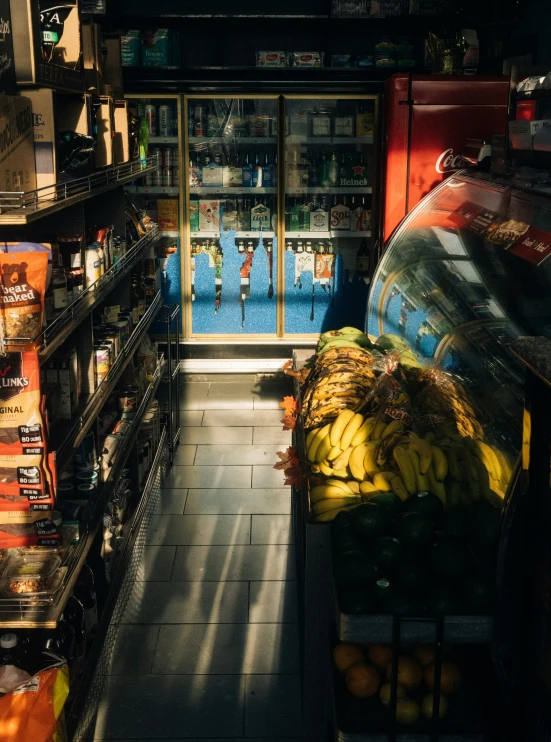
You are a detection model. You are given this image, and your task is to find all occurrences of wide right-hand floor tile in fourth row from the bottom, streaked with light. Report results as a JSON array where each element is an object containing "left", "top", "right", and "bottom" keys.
[{"left": 172, "top": 545, "right": 295, "bottom": 582}]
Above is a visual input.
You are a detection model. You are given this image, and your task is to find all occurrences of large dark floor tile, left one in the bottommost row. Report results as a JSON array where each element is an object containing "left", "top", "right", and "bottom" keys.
[{"left": 95, "top": 675, "right": 244, "bottom": 740}]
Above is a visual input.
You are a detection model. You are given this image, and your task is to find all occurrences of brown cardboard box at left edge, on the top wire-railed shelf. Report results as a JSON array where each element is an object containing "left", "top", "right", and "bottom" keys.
[{"left": 0, "top": 95, "right": 36, "bottom": 192}]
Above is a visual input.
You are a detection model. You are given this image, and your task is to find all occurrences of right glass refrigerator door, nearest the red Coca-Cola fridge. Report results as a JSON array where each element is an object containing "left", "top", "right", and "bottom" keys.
[{"left": 284, "top": 96, "right": 377, "bottom": 335}]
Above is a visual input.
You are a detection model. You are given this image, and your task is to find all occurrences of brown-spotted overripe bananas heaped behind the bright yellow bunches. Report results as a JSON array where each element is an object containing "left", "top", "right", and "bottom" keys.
[{"left": 301, "top": 346, "right": 376, "bottom": 429}]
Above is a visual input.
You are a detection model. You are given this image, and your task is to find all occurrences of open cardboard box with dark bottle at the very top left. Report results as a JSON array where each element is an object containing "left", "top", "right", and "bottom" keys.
[{"left": 10, "top": 0, "right": 84, "bottom": 92}]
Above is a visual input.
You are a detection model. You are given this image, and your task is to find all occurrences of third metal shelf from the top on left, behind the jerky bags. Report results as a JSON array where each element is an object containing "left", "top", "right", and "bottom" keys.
[{"left": 50, "top": 291, "right": 162, "bottom": 471}]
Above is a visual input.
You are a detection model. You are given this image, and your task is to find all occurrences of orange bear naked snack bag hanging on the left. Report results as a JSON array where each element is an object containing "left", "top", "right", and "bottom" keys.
[{"left": 0, "top": 252, "right": 48, "bottom": 350}]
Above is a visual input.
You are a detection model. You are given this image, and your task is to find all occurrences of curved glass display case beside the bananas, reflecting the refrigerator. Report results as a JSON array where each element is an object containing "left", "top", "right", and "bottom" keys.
[{"left": 367, "top": 171, "right": 551, "bottom": 501}]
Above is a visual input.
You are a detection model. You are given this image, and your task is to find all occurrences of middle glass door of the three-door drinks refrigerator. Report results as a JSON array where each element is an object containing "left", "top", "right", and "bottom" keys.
[{"left": 185, "top": 96, "right": 278, "bottom": 337}]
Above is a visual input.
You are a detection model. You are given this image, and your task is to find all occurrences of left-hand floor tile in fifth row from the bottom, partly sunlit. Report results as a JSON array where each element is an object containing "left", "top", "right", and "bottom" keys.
[{"left": 146, "top": 514, "right": 251, "bottom": 546}]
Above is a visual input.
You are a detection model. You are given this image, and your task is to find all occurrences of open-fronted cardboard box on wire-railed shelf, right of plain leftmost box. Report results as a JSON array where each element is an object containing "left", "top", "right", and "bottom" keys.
[{"left": 25, "top": 88, "right": 93, "bottom": 195}]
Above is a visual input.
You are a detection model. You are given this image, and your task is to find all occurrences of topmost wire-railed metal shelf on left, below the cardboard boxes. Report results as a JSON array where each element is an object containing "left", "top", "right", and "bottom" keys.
[{"left": 0, "top": 157, "right": 159, "bottom": 226}]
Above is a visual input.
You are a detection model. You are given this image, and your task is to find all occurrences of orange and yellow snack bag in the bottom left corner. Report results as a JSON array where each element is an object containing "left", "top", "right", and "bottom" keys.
[{"left": 0, "top": 660, "right": 69, "bottom": 742}]
